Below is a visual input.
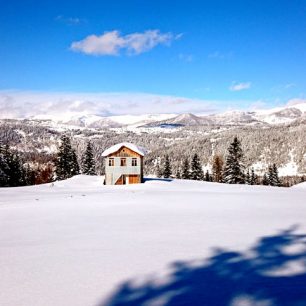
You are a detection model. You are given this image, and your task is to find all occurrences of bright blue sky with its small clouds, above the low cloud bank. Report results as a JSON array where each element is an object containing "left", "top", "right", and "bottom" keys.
[{"left": 0, "top": 0, "right": 306, "bottom": 115}]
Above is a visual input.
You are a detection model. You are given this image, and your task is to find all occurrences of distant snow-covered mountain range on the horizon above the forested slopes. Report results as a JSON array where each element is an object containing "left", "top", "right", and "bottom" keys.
[{"left": 23, "top": 103, "right": 306, "bottom": 128}]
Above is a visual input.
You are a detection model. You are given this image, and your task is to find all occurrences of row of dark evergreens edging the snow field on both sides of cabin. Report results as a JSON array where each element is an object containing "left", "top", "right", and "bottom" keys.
[{"left": 0, "top": 134, "right": 303, "bottom": 187}]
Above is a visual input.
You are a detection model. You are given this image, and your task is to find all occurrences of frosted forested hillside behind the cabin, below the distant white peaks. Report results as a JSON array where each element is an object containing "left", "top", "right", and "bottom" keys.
[{"left": 0, "top": 120, "right": 306, "bottom": 180}]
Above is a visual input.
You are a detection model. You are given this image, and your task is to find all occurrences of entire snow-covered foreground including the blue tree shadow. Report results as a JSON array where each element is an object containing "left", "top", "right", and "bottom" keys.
[{"left": 0, "top": 176, "right": 306, "bottom": 306}]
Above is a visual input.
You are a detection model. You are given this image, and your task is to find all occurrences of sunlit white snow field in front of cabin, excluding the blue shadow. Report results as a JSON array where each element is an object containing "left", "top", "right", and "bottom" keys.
[{"left": 0, "top": 176, "right": 306, "bottom": 306}]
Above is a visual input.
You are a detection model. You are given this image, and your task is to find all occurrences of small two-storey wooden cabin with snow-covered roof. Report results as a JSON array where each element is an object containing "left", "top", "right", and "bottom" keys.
[{"left": 102, "top": 143, "right": 145, "bottom": 185}]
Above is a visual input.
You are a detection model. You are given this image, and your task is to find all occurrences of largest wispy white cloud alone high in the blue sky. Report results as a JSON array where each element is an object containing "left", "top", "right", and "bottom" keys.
[{"left": 70, "top": 30, "right": 182, "bottom": 55}]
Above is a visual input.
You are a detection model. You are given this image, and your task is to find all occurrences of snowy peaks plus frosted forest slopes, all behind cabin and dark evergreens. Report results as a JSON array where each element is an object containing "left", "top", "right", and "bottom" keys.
[{"left": 0, "top": 103, "right": 306, "bottom": 176}]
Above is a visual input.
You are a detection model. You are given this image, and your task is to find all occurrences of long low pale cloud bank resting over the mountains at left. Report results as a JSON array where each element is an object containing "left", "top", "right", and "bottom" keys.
[{"left": 0, "top": 91, "right": 218, "bottom": 120}]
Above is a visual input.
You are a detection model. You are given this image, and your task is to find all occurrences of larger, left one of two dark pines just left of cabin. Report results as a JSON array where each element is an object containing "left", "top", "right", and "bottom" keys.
[{"left": 55, "top": 135, "right": 79, "bottom": 180}]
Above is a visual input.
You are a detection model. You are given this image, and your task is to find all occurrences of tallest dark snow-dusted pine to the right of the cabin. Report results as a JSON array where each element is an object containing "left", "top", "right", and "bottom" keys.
[{"left": 223, "top": 137, "right": 245, "bottom": 184}]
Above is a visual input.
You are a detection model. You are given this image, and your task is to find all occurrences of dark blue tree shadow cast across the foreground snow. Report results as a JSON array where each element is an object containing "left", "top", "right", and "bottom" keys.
[{"left": 99, "top": 227, "right": 306, "bottom": 306}]
